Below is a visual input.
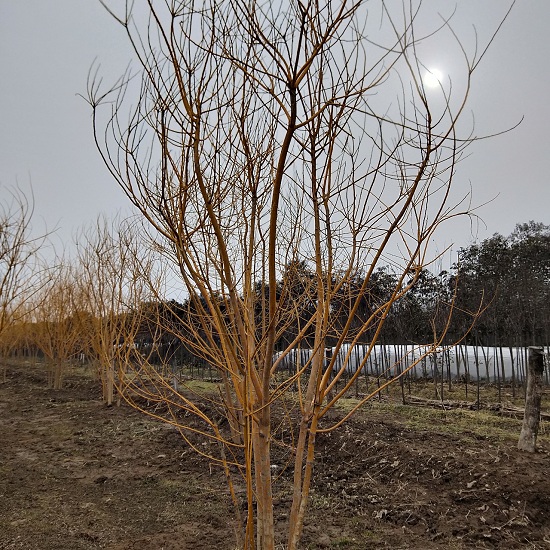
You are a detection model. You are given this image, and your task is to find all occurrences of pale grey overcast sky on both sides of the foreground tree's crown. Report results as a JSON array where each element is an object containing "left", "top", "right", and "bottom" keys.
[{"left": 0, "top": 0, "right": 550, "bottom": 264}]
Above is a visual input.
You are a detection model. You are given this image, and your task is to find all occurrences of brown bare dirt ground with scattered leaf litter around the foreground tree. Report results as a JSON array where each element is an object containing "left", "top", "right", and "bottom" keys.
[{"left": 0, "top": 366, "right": 550, "bottom": 550}]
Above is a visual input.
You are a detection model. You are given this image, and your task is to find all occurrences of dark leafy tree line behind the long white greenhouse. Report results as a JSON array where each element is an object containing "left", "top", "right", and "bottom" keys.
[{"left": 154, "top": 221, "right": 550, "bottom": 362}]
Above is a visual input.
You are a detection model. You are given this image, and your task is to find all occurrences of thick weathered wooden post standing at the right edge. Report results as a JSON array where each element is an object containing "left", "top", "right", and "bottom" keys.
[{"left": 518, "top": 346, "right": 544, "bottom": 453}]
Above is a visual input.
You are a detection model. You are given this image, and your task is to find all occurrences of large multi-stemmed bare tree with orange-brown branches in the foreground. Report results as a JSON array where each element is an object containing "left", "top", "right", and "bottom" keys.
[{"left": 88, "top": 0, "right": 516, "bottom": 549}]
